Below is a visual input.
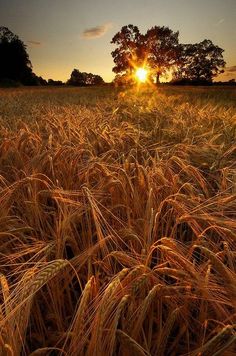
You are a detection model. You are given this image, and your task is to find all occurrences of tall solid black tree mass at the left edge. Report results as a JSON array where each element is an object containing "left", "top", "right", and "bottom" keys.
[{"left": 0, "top": 27, "right": 37, "bottom": 85}]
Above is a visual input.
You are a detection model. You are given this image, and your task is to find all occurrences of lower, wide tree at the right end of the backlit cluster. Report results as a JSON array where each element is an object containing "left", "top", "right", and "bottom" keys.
[{"left": 174, "top": 40, "right": 225, "bottom": 84}]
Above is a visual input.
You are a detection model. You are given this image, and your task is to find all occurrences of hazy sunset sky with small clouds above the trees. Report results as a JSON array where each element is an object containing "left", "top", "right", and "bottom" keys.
[{"left": 0, "top": 0, "right": 236, "bottom": 82}]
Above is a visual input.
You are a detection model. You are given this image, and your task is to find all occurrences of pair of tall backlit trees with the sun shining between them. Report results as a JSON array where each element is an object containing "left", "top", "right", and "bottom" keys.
[{"left": 111, "top": 25, "right": 179, "bottom": 82}]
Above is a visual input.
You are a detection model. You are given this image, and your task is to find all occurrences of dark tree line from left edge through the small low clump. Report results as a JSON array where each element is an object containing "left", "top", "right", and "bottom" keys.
[{"left": 0, "top": 26, "right": 104, "bottom": 86}]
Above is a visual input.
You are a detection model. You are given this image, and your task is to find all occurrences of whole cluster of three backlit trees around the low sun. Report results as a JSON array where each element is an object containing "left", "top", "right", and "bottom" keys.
[{"left": 111, "top": 25, "right": 225, "bottom": 84}]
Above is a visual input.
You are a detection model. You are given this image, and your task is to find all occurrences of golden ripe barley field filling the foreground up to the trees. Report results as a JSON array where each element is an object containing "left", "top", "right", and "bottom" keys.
[{"left": 0, "top": 87, "right": 236, "bottom": 356}]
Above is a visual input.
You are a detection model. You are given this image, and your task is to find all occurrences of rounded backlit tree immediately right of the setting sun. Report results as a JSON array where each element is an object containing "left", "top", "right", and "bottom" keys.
[{"left": 144, "top": 26, "right": 180, "bottom": 83}]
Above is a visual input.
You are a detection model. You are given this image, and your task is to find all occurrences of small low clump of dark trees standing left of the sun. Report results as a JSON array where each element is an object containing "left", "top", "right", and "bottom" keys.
[{"left": 67, "top": 69, "right": 104, "bottom": 86}]
